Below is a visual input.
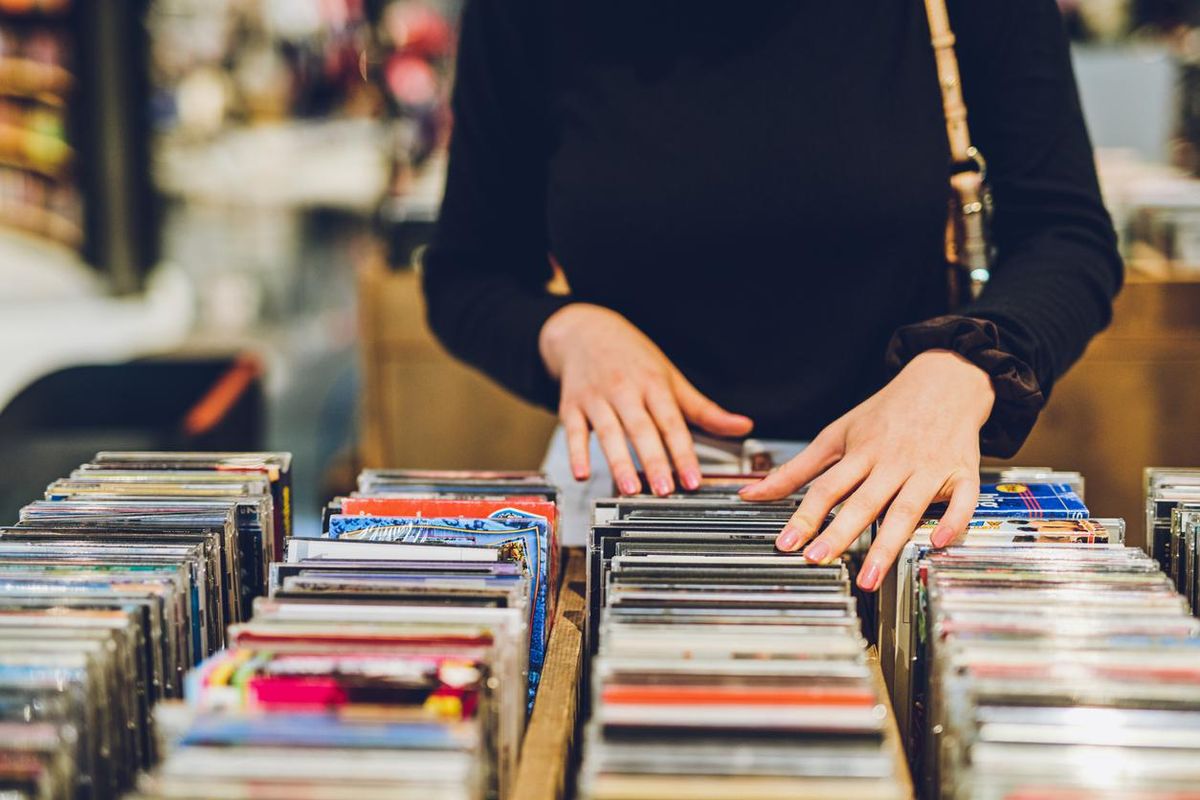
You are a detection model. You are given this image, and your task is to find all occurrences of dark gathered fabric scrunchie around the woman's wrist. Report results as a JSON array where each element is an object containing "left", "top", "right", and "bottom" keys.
[{"left": 887, "top": 315, "right": 1046, "bottom": 458}]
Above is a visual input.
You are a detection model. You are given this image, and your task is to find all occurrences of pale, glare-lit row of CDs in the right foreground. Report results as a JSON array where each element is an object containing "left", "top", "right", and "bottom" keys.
[{"left": 917, "top": 543, "right": 1200, "bottom": 799}]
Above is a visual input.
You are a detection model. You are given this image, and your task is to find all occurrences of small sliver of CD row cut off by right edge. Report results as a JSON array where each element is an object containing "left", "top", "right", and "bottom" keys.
[{"left": 1146, "top": 467, "right": 1200, "bottom": 610}]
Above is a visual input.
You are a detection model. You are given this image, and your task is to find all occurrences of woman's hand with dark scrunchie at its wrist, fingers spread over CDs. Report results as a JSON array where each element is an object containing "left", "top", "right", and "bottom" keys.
[{"left": 742, "top": 350, "right": 995, "bottom": 591}]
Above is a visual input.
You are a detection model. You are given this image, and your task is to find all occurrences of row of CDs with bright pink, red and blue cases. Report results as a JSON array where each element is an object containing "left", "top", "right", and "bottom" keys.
[{"left": 131, "top": 470, "right": 558, "bottom": 800}]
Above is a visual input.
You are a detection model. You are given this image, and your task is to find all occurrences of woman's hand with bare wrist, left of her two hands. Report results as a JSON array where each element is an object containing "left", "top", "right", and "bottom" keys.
[{"left": 538, "top": 303, "right": 754, "bottom": 495}]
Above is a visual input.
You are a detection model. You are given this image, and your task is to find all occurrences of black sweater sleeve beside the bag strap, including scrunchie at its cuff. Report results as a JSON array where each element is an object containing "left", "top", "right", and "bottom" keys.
[{"left": 892, "top": 0, "right": 1123, "bottom": 456}]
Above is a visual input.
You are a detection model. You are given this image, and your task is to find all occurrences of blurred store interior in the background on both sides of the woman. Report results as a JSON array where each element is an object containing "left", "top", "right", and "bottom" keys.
[{"left": 0, "top": 0, "right": 1200, "bottom": 543}]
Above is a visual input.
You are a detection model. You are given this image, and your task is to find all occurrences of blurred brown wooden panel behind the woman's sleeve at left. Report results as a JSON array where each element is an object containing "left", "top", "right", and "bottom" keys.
[{"left": 358, "top": 261, "right": 554, "bottom": 469}]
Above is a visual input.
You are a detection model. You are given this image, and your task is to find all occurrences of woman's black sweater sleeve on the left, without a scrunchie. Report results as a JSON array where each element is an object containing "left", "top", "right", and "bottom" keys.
[{"left": 422, "top": 0, "right": 568, "bottom": 408}]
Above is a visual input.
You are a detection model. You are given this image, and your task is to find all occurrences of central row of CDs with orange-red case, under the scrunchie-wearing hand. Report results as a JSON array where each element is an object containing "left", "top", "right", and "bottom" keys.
[{"left": 580, "top": 499, "right": 908, "bottom": 800}]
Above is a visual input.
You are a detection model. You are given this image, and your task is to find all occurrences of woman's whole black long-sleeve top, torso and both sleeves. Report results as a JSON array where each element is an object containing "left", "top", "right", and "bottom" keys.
[{"left": 424, "top": 0, "right": 1122, "bottom": 453}]
